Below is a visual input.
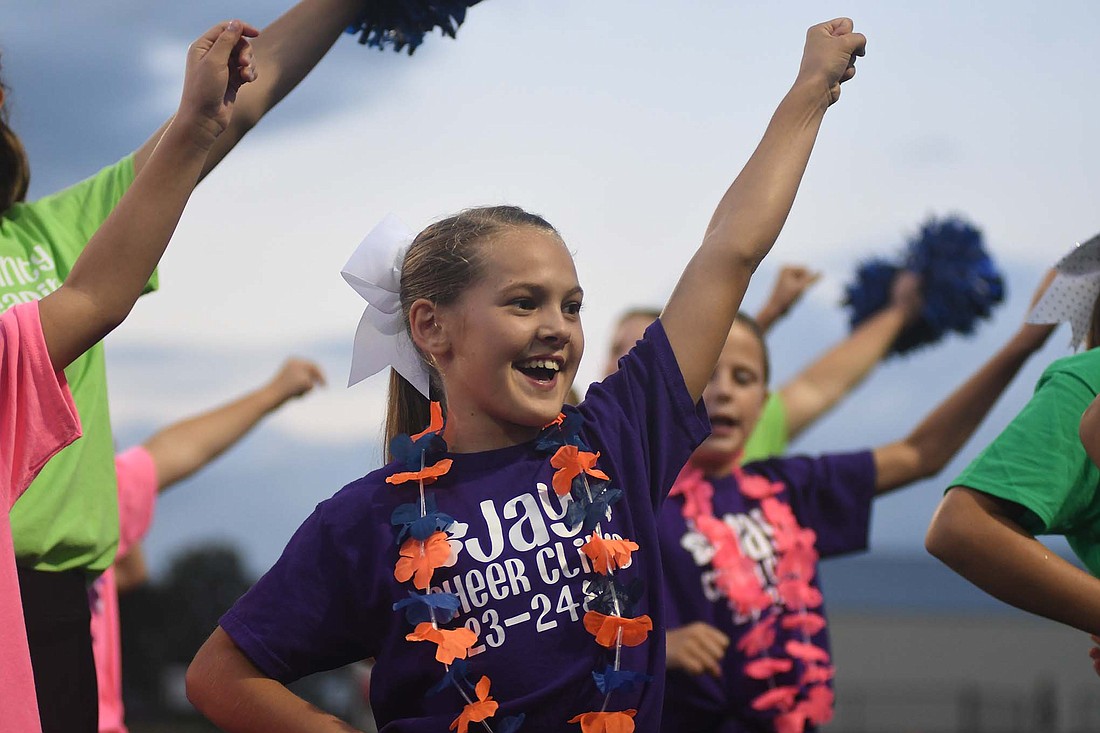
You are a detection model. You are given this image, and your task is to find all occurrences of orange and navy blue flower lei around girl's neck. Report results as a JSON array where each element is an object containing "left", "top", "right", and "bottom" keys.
[{"left": 386, "top": 402, "right": 652, "bottom": 733}]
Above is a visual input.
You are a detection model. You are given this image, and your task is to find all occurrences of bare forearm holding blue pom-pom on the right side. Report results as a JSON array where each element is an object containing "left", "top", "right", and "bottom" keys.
[{"left": 779, "top": 272, "right": 922, "bottom": 438}]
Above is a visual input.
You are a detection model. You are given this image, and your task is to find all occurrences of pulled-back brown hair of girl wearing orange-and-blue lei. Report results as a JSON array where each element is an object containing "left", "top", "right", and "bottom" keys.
[{"left": 386, "top": 206, "right": 560, "bottom": 458}]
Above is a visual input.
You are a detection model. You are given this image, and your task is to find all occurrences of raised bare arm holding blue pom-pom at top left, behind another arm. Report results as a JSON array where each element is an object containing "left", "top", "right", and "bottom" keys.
[{"left": 134, "top": 0, "right": 364, "bottom": 178}]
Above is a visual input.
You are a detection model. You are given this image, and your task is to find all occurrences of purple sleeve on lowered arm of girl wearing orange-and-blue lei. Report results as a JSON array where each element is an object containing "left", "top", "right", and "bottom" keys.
[{"left": 219, "top": 494, "right": 389, "bottom": 685}]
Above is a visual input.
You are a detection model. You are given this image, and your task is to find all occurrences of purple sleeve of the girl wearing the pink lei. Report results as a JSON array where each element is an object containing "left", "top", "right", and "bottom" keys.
[{"left": 765, "top": 450, "right": 876, "bottom": 558}]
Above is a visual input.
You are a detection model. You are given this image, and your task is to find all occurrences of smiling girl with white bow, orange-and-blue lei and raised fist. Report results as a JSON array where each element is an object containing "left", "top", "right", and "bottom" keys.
[{"left": 187, "top": 19, "right": 865, "bottom": 733}]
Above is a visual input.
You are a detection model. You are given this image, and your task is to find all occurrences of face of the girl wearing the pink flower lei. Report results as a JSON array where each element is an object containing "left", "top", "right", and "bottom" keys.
[{"left": 692, "top": 321, "right": 768, "bottom": 475}]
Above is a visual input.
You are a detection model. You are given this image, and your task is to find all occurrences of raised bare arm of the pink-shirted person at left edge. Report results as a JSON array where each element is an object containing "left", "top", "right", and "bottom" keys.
[{"left": 39, "top": 21, "right": 256, "bottom": 369}]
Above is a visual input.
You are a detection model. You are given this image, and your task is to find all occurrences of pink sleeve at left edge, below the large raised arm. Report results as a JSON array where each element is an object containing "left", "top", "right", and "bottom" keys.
[{"left": 0, "top": 302, "right": 80, "bottom": 501}]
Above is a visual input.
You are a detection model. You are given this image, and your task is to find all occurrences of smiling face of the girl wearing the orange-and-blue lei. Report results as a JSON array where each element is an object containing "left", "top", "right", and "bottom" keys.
[{"left": 426, "top": 226, "right": 584, "bottom": 452}]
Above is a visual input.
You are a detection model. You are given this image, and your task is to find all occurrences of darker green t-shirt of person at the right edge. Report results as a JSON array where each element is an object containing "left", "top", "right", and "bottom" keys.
[{"left": 952, "top": 349, "right": 1100, "bottom": 577}]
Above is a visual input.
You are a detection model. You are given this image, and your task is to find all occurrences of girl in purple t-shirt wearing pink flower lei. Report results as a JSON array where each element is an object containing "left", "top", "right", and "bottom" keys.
[{"left": 659, "top": 269, "right": 1051, "bottom": 733}]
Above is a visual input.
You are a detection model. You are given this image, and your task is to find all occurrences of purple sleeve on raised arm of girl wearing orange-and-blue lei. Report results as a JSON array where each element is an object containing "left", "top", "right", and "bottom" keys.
[{"left": 580, "top": 319, "right": 711, "bottom": 505}]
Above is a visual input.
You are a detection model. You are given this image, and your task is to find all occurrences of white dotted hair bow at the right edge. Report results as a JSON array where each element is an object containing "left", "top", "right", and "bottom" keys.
[{"left": 1027, "top": 234, "right": 1100, "bottom": 348}]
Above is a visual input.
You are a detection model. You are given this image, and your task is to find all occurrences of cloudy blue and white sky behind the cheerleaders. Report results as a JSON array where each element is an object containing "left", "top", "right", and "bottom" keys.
[{"left": 0, "top": 0, "right": 1100, "bottom": 572}]
